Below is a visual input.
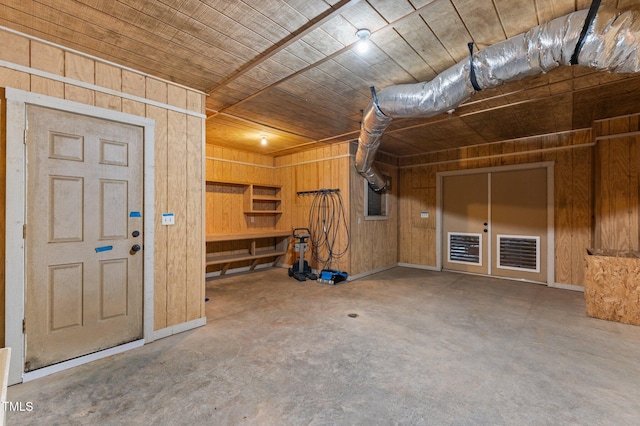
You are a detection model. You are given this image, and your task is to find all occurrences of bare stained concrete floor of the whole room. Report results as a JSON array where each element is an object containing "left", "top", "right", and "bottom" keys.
[{"left": 7, "top": 268, "right": 640, "bottom": 425}]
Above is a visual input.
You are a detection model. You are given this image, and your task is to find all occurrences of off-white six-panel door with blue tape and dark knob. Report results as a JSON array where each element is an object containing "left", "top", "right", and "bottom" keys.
[{"left": 24, "top": 105, "right": 143, "bottom": 371}]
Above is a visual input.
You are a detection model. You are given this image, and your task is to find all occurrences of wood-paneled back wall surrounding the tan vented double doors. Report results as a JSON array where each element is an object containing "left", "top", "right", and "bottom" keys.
[{"left": 398, "top": 130, "right": 594, "bottom": 286}]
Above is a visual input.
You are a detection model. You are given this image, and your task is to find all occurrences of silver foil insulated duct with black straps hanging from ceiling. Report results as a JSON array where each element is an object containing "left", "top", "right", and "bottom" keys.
[{"left": 356, "top": 2, "right": 640, "bottom": 191}]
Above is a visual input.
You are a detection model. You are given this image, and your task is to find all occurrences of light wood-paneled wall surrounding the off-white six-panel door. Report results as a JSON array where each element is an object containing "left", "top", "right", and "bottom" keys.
[{"left": 0, "top": 31, "right": 204, "bottom": 330}]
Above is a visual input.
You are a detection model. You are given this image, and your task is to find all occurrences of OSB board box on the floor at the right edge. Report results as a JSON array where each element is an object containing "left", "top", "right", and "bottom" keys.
[{"left": 584, "top": 255, "right": 640, "bottom": 325}]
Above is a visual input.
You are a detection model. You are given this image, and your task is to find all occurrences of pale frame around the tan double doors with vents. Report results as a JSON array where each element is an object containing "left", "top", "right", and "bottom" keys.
[{"left": 436, "top": 161, "right": 555, "bottom": 287}]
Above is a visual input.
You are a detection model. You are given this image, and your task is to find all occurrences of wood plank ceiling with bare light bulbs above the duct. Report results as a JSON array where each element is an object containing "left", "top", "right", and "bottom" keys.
[{"left": 0, "top": 0, "right": 640, "bottom": 157}]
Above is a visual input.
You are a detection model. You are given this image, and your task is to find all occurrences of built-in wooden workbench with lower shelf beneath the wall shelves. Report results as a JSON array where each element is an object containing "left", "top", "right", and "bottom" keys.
[{"left": 206, "top": 230, "right": 291, "bottom": 275}]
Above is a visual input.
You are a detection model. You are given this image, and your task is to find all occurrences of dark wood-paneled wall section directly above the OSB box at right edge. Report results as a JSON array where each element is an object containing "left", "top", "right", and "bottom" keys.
[{"left": 594, "top": 115, "right": 640, "bottom": 251}]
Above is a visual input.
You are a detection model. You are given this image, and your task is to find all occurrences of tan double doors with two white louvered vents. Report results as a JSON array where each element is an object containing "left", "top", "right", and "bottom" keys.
[{"left": 442, "top": 168, "right": 548, "bottom": 282}]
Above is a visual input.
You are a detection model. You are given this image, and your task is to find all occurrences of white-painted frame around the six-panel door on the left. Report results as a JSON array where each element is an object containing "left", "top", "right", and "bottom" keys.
[{"left": 5, "top": 88, "right": 155, "bottom": 384}]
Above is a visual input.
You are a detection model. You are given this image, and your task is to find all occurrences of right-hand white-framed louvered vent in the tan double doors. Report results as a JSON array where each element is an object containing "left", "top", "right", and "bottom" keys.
[{"left": 497, "top": 235, "right": 540, "bottom": 272}]
